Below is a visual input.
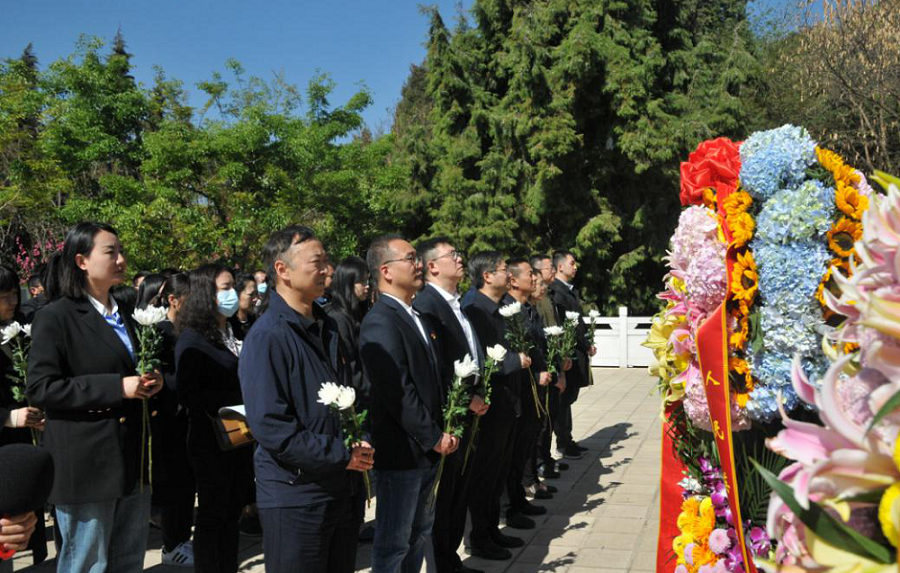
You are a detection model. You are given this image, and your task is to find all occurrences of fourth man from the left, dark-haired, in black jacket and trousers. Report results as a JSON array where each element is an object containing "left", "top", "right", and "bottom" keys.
[{"left": 463, "top": 251, "right": 531, "bottom": 560}]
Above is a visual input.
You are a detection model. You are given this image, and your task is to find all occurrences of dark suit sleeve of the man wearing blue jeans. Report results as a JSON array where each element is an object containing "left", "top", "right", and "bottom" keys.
[{"left": 360, "top": 314, "right": 443, "bottom": 453}]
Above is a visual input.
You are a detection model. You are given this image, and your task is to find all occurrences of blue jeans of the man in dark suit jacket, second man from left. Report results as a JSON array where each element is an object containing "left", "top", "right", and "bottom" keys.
[{"left": 372, "top": 466, "right": 437, "bottom": 573}]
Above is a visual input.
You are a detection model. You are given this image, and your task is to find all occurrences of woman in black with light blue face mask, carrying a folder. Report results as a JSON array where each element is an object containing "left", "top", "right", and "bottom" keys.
[{"left": 175, "top": 264, "right": 253, "bottom": 573}]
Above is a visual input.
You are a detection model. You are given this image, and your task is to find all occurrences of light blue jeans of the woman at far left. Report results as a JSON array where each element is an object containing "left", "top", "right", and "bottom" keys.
[{"left": 56, "top": 487, "right": 150, "bottom": 573}]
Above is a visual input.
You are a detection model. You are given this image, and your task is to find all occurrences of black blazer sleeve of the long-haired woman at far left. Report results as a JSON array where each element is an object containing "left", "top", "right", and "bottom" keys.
[{"left": 25, "top": 310, "right": 124, "bottom": 410}]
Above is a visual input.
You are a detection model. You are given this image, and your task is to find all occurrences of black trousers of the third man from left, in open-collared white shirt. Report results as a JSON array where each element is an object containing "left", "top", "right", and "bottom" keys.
[{"left": 431, "top": 412, "right": 474, "bottom": 573}]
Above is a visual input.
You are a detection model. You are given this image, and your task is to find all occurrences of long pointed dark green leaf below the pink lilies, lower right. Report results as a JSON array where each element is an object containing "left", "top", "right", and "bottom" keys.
[{"left": 750, "top": 459, "right": 895, "bottom": 564}]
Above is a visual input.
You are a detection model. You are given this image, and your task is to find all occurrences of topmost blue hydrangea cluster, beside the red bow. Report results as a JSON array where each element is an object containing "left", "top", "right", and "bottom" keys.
[{"left": 740, "top": 124, "right": 816, "bottom": 201}]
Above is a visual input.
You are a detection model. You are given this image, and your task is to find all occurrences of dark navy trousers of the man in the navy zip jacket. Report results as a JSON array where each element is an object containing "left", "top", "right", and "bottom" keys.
[{"left": 259, "top": 496, "right": 362, "bottom": 573}]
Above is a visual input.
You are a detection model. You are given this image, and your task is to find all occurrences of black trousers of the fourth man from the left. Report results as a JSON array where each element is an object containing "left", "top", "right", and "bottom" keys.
[{"left": 469, "top": 388, "right": 516, "bottom": 547}]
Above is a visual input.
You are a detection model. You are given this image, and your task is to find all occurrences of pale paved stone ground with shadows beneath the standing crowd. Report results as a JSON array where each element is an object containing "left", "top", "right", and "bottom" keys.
[{"left": 14, "top": 368, "right": 661, "bottom": 573}]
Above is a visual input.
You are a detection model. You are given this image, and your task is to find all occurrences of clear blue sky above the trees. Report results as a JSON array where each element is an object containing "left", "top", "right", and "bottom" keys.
[{"left": 0, "top": 0, "right": 790, "bottom": 131}]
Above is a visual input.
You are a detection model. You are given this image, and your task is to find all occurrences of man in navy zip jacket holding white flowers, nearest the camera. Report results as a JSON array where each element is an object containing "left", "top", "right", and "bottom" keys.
[{"left": 240, "top": 226, "right": 374, "bottom": 573}]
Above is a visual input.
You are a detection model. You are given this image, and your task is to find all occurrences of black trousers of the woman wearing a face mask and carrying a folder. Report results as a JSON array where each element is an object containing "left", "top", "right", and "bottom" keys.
[{"left": 188, "top": 418, "right": 253, "bottom": 573}]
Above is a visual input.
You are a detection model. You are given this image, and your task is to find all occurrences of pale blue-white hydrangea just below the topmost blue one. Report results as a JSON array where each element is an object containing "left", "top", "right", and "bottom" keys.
[{"left": 756, "top": 179, "right": 834, "bottom": 243}]
